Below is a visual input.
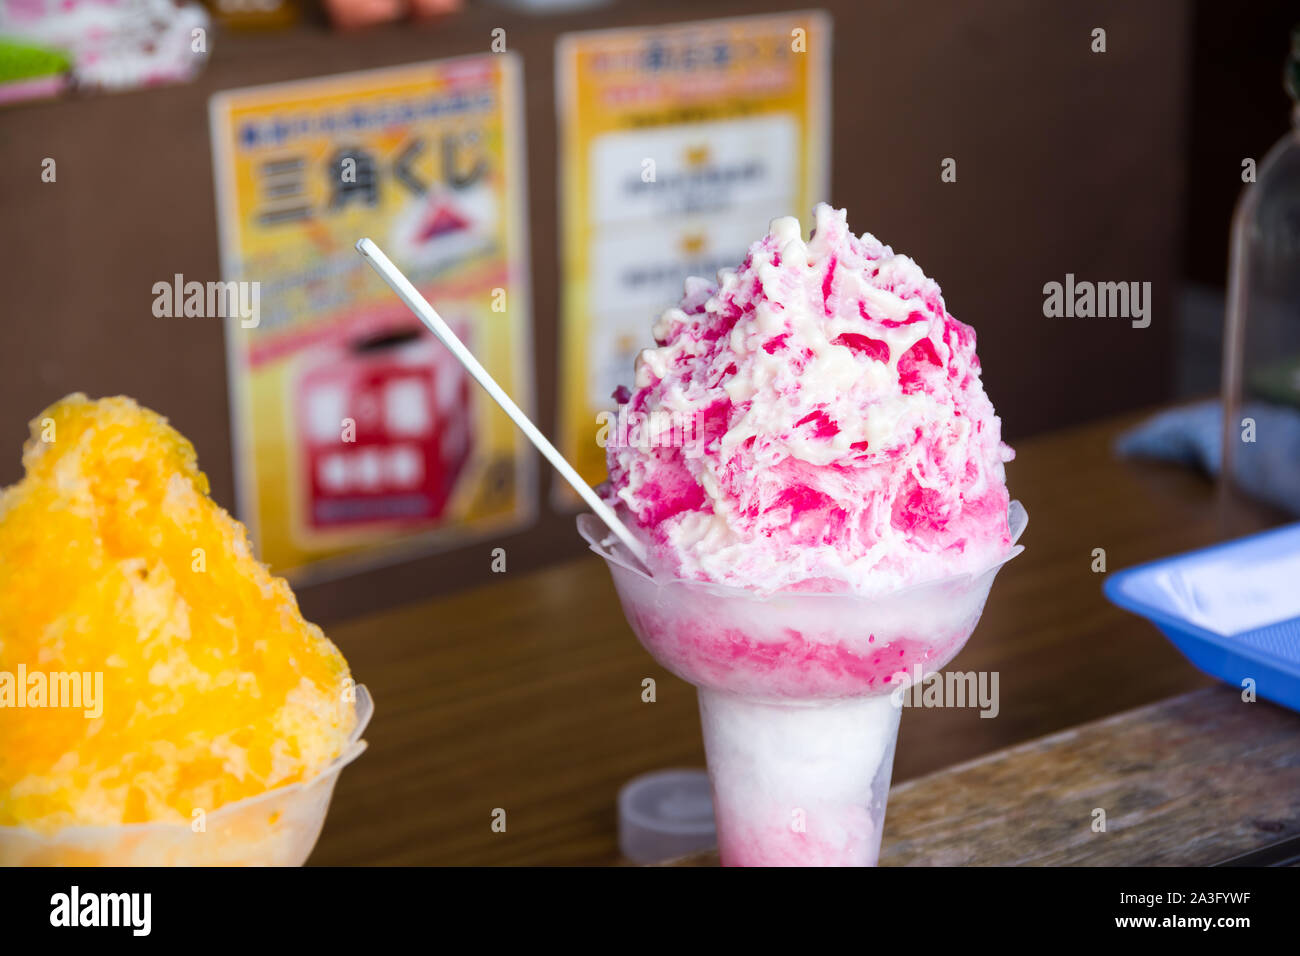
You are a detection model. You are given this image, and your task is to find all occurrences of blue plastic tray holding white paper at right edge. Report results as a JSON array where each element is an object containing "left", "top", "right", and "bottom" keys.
[{"left": 1104, "top": 524, "right": 1300, "bottom": 710}]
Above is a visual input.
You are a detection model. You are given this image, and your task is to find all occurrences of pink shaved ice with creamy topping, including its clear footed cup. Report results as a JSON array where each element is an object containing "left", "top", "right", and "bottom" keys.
[{"left": 579, "top": 206, "right": 1027, "bottom": 866}]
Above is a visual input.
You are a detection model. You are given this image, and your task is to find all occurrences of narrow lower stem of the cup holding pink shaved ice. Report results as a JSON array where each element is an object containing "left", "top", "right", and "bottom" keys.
[{"left": 699, "top": 688, "right": 900, "bottom": 866}]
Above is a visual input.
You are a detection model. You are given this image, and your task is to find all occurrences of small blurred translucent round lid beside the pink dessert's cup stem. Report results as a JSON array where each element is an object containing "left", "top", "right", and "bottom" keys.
[{"left": 619, "top": 770, "right": 718, "bottom": 864}]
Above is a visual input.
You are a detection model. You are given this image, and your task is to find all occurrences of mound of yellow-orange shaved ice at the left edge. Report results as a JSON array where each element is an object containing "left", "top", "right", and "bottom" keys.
[{"left": 0, "top": 394, "right": 356, "bottom": 832}]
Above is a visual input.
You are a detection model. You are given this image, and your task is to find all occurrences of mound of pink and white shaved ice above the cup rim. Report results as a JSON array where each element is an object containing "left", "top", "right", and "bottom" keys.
[{"left": 607, "top": 204, "right": 1014, "bottom": 596}]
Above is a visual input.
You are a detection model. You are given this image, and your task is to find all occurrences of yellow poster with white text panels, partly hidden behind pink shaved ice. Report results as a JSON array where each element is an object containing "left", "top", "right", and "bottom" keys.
[{"left": 556, "top": 10, "right": 831, "bottom": 503}]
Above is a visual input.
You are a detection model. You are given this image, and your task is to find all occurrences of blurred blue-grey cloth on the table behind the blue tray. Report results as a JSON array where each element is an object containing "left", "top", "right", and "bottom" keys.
[{"left": 1115, "top": 401, "right": 1300, "bottom": 515}]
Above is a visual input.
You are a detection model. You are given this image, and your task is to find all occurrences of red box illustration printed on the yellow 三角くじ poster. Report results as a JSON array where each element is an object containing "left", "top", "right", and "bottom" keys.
[{"left": 295, "top": 328, "right": 472, "bottom": 533}]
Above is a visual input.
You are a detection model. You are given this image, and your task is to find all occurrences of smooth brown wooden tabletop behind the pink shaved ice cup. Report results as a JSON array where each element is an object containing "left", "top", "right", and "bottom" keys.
[{"left": 312, "top": 416, "right": 1277, "bottom": 865}]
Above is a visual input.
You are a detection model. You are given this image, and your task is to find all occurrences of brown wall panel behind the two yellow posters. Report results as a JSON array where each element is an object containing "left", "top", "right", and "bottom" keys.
[{"left": 0, "top": 0, "right": 1190, "bottom": 620}]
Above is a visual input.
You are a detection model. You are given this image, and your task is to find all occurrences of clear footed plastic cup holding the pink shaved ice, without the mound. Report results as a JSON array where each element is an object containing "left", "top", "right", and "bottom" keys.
[{"left": 579, "top": 502, "right": 1028, "bottom": 866}]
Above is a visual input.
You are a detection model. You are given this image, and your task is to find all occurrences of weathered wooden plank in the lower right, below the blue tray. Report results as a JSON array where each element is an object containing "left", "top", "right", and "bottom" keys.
[{"left": 880, "top": 687, "right": 1300, "bottom": 866}]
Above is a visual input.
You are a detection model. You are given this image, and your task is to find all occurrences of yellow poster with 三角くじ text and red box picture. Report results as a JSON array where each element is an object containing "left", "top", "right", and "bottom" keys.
[{"left": 211, "top": 53, "right": 536, "bottom": 579}]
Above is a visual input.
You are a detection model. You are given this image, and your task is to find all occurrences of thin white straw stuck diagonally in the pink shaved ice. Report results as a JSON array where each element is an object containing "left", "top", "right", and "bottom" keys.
[{"left": 356, "top": 239, "right": 646, "bottom": 564}]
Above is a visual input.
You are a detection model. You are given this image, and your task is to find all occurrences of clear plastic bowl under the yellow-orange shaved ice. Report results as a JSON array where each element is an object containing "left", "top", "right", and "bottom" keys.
[{"left": 0, "top": 684, "right": 374, "bottom": 866}]
